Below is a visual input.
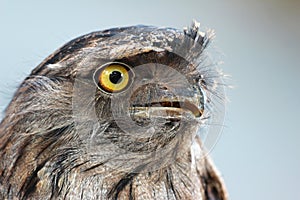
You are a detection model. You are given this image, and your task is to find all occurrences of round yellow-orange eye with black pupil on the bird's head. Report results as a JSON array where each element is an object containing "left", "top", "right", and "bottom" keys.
[{"left": 94, "top": 62, "right": 133, "bottom": 93}]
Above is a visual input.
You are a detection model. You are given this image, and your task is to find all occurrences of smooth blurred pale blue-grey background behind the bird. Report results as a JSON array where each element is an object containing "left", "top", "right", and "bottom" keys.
[{"left": 0, "top": 0, "right": 300, "bottom": 200}]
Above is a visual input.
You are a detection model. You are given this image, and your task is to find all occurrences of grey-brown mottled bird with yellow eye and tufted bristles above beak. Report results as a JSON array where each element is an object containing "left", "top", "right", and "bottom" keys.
[{"left": 0, "top": 21, "right": 228, "bottom": 200}]
